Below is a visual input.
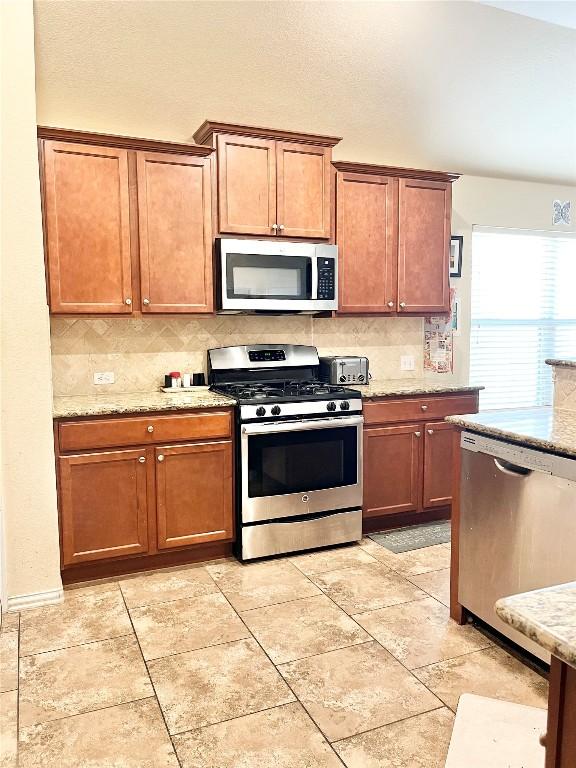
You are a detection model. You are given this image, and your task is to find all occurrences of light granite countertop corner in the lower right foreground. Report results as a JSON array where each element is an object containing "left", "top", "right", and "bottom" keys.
[{"left": 496, "top": 581, "right": 576, "bottom": 667}]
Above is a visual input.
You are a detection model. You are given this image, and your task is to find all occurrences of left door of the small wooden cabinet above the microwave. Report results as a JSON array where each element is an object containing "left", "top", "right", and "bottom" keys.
[{"left": 217, "top": 136, "right": 276, "bottom": 235}]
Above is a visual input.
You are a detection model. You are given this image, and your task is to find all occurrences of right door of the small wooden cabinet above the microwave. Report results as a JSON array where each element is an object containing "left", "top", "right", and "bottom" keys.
[{"left": 276, "top": 141, "right": 331, "bottom": 239}]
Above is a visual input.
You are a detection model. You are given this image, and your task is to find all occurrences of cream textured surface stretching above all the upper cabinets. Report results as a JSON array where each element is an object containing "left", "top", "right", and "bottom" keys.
[{"left": 35, "top": 0, "right": 576, "bottom": 184}]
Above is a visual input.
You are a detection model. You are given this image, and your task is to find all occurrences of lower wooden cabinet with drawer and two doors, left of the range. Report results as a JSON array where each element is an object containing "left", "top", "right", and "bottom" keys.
[{"left": 55, "top": 409, "right": 234, "bottom": 569}]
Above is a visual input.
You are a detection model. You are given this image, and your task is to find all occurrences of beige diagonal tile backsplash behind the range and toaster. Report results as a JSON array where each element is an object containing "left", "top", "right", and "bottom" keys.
[{"left": 51, "top": 315, "right": 423, "bottom": 396}]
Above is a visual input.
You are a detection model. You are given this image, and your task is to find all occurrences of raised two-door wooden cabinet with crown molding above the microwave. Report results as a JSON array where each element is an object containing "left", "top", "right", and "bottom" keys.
[{"left": 194, "top": 122, "right": 340, "bottom": 240}]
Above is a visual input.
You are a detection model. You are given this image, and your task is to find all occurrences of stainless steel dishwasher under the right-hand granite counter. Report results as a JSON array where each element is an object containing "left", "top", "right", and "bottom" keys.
[{"left": 458, "top": 432, "right": 576, "bottom": 662}]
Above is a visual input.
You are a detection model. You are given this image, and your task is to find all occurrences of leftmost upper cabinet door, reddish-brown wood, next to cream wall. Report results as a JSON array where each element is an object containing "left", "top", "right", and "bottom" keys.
[{"left": 43, "top": 141, "right": 132, "bottom": 314}]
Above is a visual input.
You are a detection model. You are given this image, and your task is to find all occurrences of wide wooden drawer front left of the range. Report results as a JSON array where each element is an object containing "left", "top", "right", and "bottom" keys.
[{"left": 58, "top": 411, "right": 232, "bottom": 451}]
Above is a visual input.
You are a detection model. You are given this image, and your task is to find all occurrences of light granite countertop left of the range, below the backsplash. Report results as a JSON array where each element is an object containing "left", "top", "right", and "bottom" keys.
[{"left": 53, "top": 387, "right": 236, "bottom": 419}]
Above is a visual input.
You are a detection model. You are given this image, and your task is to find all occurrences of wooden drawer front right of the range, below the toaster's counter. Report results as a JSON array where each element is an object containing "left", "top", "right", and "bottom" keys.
[{"left": 364, "top": 394, "right": 478, "bottom": 424}]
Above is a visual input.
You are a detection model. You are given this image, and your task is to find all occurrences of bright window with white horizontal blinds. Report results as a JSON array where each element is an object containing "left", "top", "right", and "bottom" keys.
[{"left": 470, "top": 227, "right": 576, "bottom": 410}]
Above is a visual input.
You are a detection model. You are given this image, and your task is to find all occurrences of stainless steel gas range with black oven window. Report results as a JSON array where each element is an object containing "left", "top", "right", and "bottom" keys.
[{"left": 208, "top": 344, "right": 363, "bottom": 560}]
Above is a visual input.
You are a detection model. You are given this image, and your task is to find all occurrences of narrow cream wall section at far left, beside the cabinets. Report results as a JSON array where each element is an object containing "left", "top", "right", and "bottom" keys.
[{"left": 0, "top": 0, "right": 62, "bottom": 607}]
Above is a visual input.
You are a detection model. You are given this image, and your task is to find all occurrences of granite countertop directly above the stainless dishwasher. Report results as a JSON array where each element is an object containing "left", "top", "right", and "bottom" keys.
[{"left": 446, "top": 407, "right": 576, "bottom": 458}]
